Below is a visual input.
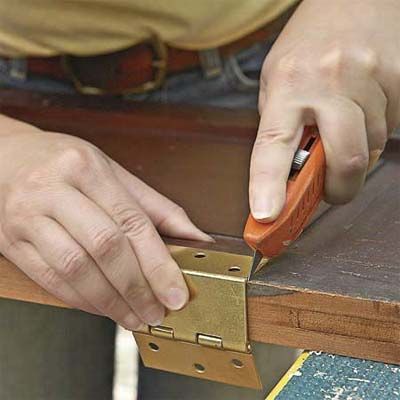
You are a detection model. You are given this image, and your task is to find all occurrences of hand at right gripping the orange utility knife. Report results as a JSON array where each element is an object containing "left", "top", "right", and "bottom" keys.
[{"left": 249, "top": 0, "right": 400, "bottom": 222}]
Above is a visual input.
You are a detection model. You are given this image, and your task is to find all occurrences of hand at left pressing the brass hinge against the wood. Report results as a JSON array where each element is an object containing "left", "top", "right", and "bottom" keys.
[{"left": 0, "top": 116, "right": 212, "bottom": 330}]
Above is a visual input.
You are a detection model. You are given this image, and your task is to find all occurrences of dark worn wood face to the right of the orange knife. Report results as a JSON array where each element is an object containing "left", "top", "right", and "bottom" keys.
[{"left": 252, "top": 157, "right": 400, "bottom": 302}]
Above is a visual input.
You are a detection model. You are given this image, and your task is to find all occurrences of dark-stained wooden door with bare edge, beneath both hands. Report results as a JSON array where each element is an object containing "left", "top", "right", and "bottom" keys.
[{"left": 0, "top": 91, "right": 400, "bottom": 364}]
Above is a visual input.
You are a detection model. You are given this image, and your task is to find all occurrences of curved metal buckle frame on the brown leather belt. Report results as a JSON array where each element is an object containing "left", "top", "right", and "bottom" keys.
[{"left": 61, "top": 35, "right": 168, "bottom": 96}]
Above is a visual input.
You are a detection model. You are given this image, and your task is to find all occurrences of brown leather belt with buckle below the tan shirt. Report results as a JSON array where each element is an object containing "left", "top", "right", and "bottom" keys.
[{"left": 18, "top": 7, "right": 294, "bottom": 95}]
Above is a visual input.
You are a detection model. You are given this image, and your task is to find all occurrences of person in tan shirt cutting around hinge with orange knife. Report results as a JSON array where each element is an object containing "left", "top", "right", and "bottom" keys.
[{"left": 0, "top": 0, "right": 400, "bottom": 400}]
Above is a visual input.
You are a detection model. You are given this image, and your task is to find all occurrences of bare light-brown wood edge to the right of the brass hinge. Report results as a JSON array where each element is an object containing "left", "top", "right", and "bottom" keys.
[{"left": 248, "top": 284, "right": 400, "bottom": 364}]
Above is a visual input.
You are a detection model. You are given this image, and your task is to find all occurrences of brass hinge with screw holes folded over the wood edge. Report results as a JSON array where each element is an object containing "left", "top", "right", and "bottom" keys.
[{"left": 134, "top": 246, "right": 261, "bottom": 389}]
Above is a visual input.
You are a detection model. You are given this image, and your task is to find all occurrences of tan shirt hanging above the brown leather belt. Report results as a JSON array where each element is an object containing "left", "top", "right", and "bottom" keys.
[{"left": 0, "top": 0, "right": 296, "bottom": 56}]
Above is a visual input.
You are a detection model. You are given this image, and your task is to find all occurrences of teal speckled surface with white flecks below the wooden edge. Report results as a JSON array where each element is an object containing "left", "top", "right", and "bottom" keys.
[{"left": 276, "top": 352, "right": 400, "bottom": 400}]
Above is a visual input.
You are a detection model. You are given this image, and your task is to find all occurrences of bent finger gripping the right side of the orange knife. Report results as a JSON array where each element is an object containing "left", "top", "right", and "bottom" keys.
[{"left": 315, "top": 97, "right": 369, "bottom": 204}]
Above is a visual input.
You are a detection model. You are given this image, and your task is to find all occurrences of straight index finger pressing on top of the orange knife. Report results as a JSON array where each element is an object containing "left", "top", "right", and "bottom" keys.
[{"left": 249, "top": 95, "right": 304, "bottom": 222}]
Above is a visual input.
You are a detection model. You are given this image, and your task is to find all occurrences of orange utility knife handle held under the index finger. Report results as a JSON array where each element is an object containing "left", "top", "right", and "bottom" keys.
[{"left": 243, "top": 126, "right": 325, "bottom": 258}]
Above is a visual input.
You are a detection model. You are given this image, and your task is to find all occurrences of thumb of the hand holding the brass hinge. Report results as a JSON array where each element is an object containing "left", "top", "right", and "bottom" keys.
[{"left": 110, "top": 160, "right": 214, "bottom": 242}]
